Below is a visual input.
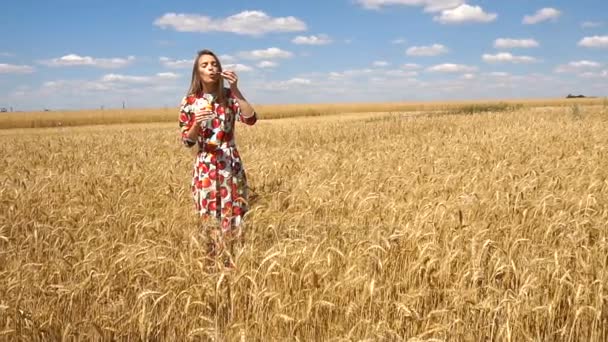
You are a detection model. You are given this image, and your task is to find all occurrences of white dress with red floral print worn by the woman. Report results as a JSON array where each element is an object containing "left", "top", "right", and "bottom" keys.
[{"left": 179, "top": 89, "right": 257, "bottom": 233}]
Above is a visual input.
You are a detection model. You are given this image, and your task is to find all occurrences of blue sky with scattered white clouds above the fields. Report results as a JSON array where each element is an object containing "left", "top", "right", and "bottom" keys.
[{"left": 0, "top": 0, "right": 608, "bottom": 110}]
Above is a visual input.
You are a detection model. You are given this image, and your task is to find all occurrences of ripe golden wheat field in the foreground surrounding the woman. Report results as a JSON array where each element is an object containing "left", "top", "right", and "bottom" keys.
[{"left": 0, "top": 105, "right": 608, "bottom": 341}]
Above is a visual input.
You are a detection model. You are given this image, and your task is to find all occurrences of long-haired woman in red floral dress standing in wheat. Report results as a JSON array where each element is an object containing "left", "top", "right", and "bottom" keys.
[{"left": 179, "top": 50, "right": 257, "bottom": 267}]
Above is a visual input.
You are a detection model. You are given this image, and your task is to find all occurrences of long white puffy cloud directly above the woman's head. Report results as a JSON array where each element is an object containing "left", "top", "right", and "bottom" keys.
[{"left": 154, "top": 11, "right": 306, "bottom": 36}]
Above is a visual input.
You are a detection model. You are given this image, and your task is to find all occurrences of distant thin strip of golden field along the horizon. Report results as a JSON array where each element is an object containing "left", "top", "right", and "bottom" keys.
[{"left": 0, "top": 98, "right": 606, "bottom": 129}]
